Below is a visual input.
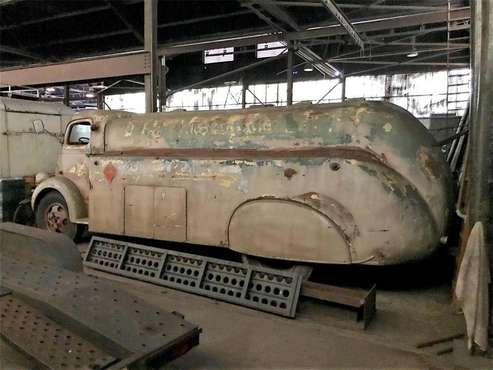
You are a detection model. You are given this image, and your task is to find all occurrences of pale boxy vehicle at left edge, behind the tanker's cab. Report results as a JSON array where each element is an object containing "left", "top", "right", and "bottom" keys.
[{"left": 0, "top": 97, "right": 74, "bottom": 222}]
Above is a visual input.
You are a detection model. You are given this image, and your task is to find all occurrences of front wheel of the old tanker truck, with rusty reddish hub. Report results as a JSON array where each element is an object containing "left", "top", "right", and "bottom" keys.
[{"left": 36, "top": 191, "right": 82, "bottom": 240}]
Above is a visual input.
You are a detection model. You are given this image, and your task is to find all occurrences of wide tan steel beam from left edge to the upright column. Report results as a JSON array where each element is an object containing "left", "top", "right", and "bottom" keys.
[{"left": 0, "top": 52, "right": 150, "bottom": 86}]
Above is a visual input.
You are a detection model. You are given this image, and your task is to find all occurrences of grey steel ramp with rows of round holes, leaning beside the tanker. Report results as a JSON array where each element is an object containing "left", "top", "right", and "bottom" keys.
[{"left": 84, "top": 237, "right": 303, "bottom": 317}]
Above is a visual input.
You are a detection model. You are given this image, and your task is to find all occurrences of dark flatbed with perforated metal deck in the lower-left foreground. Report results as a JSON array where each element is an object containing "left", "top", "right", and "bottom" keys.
[{"left": 0, "top": 256, "right": 200, "bottom": 369}]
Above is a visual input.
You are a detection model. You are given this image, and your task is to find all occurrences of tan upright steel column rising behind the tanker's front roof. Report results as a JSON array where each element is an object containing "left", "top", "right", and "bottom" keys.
[{"left": 144, "top": 0, "right": 158, "bottom": 113}]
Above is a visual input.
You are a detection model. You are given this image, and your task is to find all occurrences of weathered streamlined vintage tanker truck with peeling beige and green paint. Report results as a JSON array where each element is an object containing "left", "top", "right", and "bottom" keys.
[{"left": 31, "top": 100, "right": 451, "bottom": 265}]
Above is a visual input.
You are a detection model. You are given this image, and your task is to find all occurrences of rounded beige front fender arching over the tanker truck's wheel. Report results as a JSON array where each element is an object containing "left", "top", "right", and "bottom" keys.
[{"left": 31, "top": 176, "right": 88, "bottom": 223}]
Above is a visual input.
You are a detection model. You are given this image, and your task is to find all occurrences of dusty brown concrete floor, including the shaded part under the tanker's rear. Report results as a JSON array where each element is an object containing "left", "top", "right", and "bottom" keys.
[{"left": 0, "top": 241, "right": 478, "bottom": 369}]
